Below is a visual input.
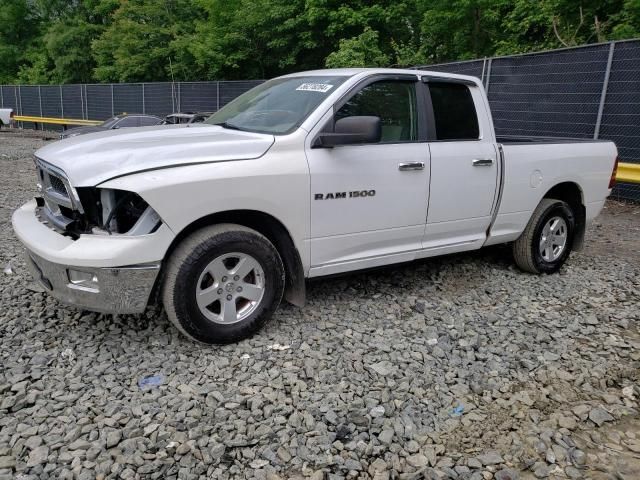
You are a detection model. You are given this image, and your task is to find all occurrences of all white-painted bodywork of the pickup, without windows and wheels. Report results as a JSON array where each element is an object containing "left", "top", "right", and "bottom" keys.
[{"left": 13, "top": 65, "right": 616, "bottom": 296}]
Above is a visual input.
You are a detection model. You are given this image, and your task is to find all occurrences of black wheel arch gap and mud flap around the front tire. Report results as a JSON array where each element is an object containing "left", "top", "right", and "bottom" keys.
[{"left": 158, "top": 210, "right": 306, "bottom": 307}]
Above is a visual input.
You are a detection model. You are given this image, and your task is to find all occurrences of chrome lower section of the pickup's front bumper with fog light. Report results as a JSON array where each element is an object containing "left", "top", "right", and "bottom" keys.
[{"left": 26, "top": 250, "right": 160, "bottom": 313}]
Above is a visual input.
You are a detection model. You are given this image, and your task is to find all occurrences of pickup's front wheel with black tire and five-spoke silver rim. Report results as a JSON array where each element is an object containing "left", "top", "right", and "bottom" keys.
[{"left": 162, "top": 224, "right": 285, "bottom": 344}]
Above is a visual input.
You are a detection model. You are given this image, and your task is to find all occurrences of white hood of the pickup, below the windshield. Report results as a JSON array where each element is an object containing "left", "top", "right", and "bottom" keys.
[{"left": 36, "top": 124, "right": 274, "bottom": 187}]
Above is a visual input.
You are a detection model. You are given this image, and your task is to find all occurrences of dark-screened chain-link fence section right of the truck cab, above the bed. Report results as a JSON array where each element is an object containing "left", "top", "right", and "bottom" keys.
[{"left": 420, "top": 40, "right": 640, "bottom": 200}]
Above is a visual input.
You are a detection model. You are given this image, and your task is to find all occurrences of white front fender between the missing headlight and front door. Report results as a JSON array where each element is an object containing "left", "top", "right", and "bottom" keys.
[{"left": 101, "top": 132, "right": 310, "bottom": 266}]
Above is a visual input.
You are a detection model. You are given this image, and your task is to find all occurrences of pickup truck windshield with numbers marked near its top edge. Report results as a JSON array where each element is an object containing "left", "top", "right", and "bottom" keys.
[{"left": 206, "top": 76, "right": 348, "bottom": 135}]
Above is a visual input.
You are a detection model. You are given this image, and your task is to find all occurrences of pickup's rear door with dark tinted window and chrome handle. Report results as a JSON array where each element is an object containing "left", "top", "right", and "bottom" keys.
[{"left": 423, "top": 79, "right": 499, "bottom": 250}]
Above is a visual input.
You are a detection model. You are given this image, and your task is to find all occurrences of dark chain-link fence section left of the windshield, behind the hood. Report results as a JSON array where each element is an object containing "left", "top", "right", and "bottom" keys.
[{"left": 0, "top": 80, "right": 262, "bottom": 124}]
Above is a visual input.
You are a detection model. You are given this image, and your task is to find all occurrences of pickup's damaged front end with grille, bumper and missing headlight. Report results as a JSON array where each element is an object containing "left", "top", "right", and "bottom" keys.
[{"left": 12, "top": 158, "right": 168, "bottom": 313}]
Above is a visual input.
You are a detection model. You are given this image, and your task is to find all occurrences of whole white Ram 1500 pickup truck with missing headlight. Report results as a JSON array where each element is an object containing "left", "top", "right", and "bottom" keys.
[{"left": 13, "top": 69, "right": 617, "bottom": 343}]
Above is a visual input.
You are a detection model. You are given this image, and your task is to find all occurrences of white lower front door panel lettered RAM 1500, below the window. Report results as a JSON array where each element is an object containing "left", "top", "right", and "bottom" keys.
[{"left": 307, "top": 135, "right": 429, "bottom": 275}]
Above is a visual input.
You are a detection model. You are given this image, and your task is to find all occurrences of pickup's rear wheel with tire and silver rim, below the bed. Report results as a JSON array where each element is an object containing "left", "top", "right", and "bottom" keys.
[{"left": 513, "top": 198, "right": 575, "bottom": 273}]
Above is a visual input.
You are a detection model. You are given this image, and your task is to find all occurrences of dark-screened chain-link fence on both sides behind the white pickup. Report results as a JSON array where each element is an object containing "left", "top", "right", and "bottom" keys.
[{"left": 0, "top": 40, "right": 640, "bottom": 200}]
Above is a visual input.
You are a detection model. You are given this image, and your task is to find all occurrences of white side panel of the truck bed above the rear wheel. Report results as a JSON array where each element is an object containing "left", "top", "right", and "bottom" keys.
[{"left": 486, "top": 142, "right": 617, "bottom": 245}]
